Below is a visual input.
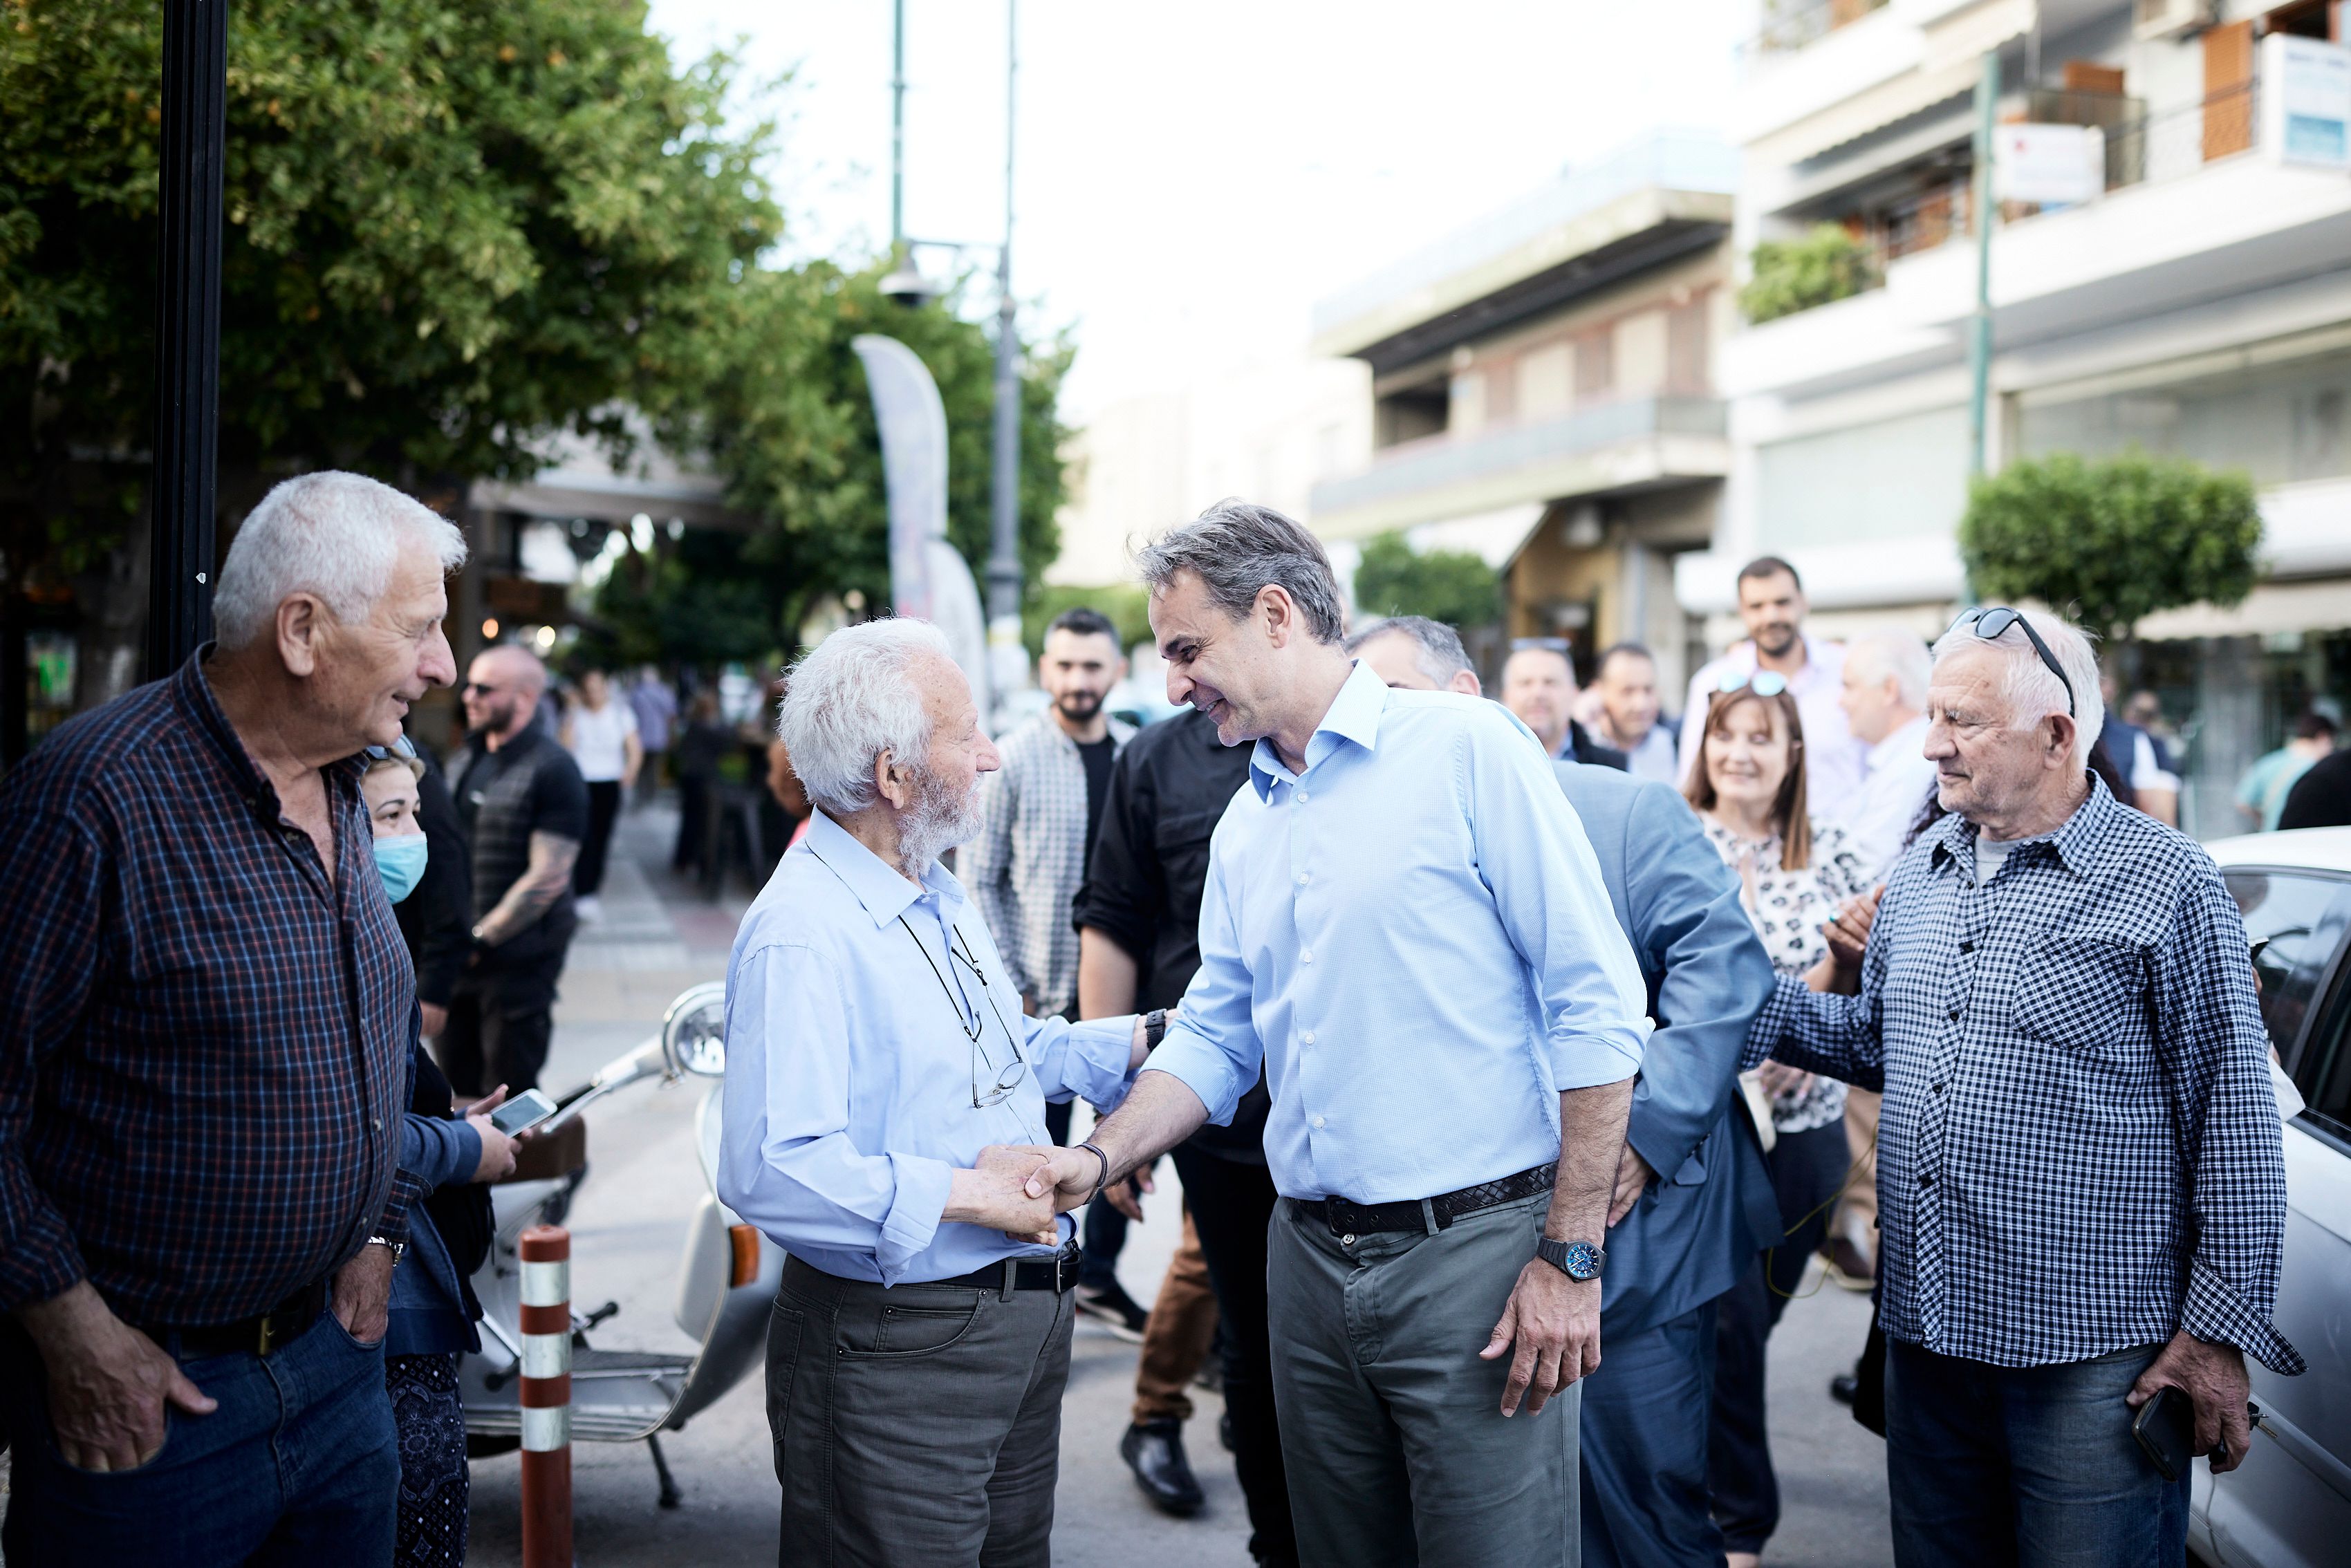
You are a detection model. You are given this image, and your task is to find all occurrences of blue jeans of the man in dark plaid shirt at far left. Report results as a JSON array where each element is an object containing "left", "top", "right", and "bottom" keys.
[{"left": 0, "top": 1312, "right": 400, "bottom": 1568}]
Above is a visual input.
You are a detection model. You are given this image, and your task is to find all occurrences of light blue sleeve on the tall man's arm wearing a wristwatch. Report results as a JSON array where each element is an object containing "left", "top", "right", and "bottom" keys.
[{"left": 1462, "top": 724, "right": 1651, "bottom": 1091}]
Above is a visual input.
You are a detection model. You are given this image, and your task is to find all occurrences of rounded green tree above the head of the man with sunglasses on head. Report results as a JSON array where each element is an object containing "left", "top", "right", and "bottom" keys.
[{"left": 1958, "top": 449, "right": 2262, "bottom": 642}]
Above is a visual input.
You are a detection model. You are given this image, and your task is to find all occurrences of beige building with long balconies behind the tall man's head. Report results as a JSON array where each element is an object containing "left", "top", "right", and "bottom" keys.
[{"left": 1310, "top": 131, "right": 1738, "bottom": 689}]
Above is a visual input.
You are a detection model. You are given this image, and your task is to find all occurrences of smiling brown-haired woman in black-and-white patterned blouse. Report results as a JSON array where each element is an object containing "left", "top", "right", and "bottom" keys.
[{"left": 1683, "top": 670, "right": 1867, "bottom": 1568}]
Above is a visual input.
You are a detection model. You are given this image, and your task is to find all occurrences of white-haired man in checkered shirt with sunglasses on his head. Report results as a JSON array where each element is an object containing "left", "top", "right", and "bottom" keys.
[{"left": 1747, "top": 609, "right": 2302, "bottom": 1568}]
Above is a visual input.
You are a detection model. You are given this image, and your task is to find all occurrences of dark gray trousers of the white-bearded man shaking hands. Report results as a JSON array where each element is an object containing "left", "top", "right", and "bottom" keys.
[{"left": 766, "top": 1258, "right": 1075, "bottom": 1568}]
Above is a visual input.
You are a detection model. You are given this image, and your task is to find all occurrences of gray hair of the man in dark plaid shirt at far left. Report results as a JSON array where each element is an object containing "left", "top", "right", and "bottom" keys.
[{"left": 212, "top": 470, "right": 465, "bottom": 648}]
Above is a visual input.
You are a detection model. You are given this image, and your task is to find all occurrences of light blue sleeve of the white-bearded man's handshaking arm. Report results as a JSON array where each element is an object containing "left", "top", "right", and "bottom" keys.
[{"left": 717, "top": 943, "right": 954, "bottom": 1286}]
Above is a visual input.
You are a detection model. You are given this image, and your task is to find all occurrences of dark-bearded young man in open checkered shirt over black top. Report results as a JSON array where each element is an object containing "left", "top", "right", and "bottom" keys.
[{"left": 962, "top": 609, "right": 1150, "bottom": 1340}]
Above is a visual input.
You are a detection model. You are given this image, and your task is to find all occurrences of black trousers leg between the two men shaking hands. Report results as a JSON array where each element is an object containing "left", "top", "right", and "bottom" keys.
[{"left": 1176, "top": 1145, "right": 1298, "bottom": 1563}]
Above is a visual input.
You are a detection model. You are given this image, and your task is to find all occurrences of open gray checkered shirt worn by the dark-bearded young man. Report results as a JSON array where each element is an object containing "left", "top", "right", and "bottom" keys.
[{"left": 957, "top": 712, "right": 1135, "bottom": 1018}]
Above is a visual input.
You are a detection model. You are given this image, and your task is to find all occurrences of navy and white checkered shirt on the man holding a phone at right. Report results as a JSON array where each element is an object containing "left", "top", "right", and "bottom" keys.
[{"left": 1747, "top": 781, "right": 2302, "bottom": 1373}]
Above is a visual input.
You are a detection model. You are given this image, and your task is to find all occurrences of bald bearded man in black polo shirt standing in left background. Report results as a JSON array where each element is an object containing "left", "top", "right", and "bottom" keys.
[{"left": 435, "top": 644, "right": 588, "bottom": 1096}]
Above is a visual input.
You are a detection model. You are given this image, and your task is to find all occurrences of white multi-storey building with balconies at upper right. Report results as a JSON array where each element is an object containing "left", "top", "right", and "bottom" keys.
[{"left": 1676, "top": 0, "right": 2351, "bottom": 834}]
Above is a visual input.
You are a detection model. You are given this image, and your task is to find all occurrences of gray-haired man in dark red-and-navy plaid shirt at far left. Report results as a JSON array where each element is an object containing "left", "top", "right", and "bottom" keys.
[{"left": 0, "top": 472, "right": 465, "bottom": 1568}]
